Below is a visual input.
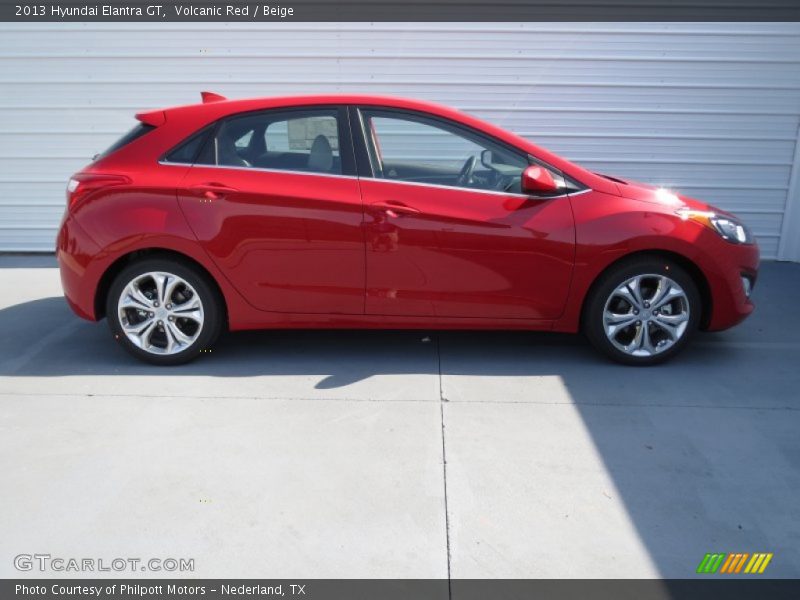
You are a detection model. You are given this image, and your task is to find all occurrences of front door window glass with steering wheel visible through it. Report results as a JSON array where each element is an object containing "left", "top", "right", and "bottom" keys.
[{"left": 362, "top": 110, "right": 529, "bottom": 193}]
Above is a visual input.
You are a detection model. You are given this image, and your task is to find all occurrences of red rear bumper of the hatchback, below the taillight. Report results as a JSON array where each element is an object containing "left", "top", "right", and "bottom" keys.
[{"left": 56, "top": 215, "right": 100, "bottom": 321}]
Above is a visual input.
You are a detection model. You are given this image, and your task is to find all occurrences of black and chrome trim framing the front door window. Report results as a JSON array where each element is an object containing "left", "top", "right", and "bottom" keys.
[{"left": 351, "top": 104, "right": 590, "bottom": 200}]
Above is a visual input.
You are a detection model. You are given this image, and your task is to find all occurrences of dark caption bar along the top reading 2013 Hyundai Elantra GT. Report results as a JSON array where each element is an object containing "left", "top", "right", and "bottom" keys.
[{"left": 0, "top": 0, "right": 800, "bottom": 23}]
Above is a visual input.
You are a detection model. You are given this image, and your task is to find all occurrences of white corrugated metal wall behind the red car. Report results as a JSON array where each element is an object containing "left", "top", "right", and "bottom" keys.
[{"left": 0, "top": 23, "right": 800, "bottom": 260}]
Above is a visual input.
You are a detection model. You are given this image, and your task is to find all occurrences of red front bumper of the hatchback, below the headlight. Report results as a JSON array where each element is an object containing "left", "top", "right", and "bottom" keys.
[{"left": 705, "top": 242, "right": 759, "bottom": 331}]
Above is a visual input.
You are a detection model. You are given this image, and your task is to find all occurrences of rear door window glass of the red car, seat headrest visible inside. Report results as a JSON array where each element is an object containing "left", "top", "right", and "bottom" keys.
[{"left": 198, "top": 109, "right": 342, "bottom": 175}]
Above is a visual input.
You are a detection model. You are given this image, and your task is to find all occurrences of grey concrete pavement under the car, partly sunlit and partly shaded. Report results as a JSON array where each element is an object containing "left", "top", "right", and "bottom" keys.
[{"left": 0, "top": 257, "right": 800, "bottom": 578}]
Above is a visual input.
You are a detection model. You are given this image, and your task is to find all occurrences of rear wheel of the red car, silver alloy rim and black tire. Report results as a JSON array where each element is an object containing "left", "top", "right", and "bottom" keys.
[{"left": 106, "top": 258, "right": 224, "bottom": 365}]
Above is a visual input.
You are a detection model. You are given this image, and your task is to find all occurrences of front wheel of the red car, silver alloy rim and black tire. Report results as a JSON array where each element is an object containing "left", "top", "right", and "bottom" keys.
[{"left": 582, "top": 256, "right": 702, "bottom": 366}]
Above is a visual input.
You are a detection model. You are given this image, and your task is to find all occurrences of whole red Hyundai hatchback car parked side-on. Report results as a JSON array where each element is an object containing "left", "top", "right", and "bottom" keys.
[{"left": 57, "top": 93, "right": 759, "bottom": 364}]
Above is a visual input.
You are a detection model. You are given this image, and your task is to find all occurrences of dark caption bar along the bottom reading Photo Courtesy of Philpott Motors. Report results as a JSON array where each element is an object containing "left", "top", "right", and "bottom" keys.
[{"left": 0, "top": 575, "right": 800, "bottom": 600}]
